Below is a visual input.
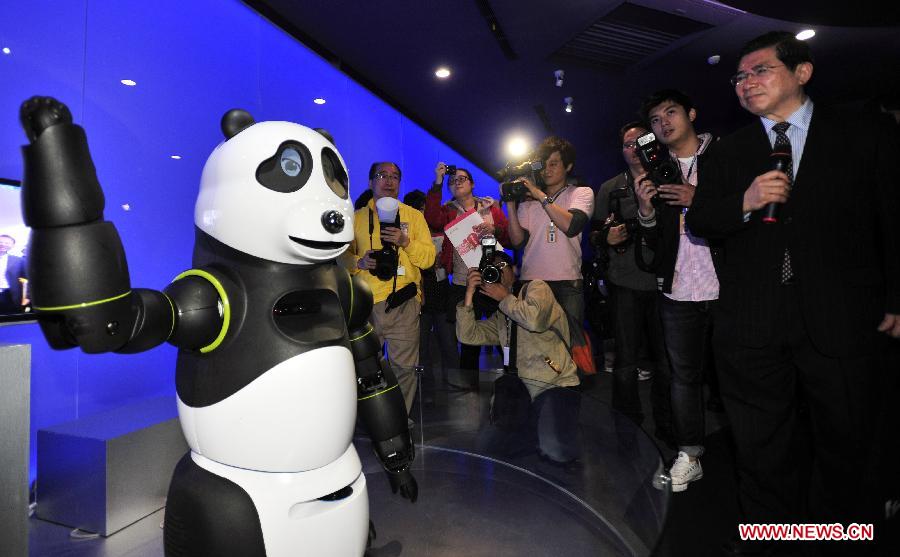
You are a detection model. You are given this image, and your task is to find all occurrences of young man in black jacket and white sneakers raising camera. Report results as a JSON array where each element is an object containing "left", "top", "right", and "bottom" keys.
[{"left": 636, "top": 89, "right": 719, "bottom": 491}]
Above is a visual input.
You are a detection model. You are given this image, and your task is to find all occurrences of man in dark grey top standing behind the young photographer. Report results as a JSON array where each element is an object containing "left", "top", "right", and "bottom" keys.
[{"left": 591, "top": 122, "right": 674, "bottom": 444}]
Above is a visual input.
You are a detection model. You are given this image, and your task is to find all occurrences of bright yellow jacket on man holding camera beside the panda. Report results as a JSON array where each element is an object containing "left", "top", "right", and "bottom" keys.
[{"left": 344, "top": 200, "right": 435, "bottom": 304}]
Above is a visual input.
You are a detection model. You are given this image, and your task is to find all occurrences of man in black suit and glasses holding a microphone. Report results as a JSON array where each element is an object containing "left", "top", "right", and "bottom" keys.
[{"left": 686, "top": 32, "right": 900, "bottom": 548}]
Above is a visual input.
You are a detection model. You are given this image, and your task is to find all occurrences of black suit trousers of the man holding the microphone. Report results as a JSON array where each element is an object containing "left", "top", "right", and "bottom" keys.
[{"left": 714, "top": 286, "right": 876, "bottom": 524}]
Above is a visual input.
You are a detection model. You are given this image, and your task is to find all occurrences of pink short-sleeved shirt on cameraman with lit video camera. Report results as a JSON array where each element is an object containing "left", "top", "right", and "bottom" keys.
[{"left": 516, "top": 186, "right": 594, "bottom": 280}]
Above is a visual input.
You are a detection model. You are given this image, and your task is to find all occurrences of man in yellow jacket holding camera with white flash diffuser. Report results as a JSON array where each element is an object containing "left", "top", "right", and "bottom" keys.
[{"left": 347, "top": 162, "right": 435, "bottom": 413}]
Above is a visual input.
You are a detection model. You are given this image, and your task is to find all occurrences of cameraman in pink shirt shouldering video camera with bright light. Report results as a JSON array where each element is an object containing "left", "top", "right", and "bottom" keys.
[{"left": 501, "top": 136, "right": 594, "bottom": 358}]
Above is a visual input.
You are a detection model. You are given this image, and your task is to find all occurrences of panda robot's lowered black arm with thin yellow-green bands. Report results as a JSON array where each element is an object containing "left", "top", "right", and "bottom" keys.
[{"left": 347, "top": 276, "right": 419, "bottom": 503}]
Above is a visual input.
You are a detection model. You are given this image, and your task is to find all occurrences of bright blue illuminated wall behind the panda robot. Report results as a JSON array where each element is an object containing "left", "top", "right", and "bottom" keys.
[{"left": 0, "top": 0, "right": 497, "bottom": 475}]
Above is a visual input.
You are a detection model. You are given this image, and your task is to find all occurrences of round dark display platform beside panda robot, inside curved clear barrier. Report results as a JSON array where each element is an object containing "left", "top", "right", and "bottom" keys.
[{"left": 30, "top": 371, "right": 670, "bottom": 557}]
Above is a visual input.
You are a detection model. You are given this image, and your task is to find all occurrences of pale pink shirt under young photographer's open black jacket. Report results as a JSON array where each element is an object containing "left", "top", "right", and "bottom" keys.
[{"left": 666, "top": 150, "right": 719, "bottom": 302}]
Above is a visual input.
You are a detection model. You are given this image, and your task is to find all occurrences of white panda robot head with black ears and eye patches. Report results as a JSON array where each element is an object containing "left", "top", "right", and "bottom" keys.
[{"left": 194, "top": 110, "right": 353, "bottom": 265}]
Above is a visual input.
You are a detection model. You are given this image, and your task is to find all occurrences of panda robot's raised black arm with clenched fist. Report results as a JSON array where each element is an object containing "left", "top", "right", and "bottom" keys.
[{"left": 20, "top": 97, "right": 222, "bottom": 353}]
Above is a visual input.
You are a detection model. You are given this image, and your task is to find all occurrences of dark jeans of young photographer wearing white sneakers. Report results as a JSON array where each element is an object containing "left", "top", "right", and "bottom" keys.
[{"left": 659, "top": 294, "right": 714, "bottom": 456}]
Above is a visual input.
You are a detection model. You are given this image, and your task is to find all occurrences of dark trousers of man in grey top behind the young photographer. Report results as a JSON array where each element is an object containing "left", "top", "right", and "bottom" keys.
[{"left": 607, "top": 284, "right": 671, "bottom": 430}]
